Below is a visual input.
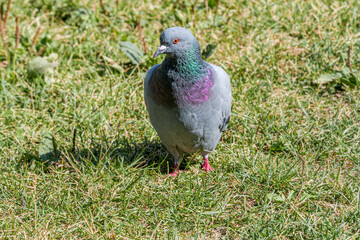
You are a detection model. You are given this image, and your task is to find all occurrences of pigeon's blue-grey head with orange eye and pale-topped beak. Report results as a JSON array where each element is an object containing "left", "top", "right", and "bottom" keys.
[{"left": 154, "top": 27, "right": 201, "bottom": 58}]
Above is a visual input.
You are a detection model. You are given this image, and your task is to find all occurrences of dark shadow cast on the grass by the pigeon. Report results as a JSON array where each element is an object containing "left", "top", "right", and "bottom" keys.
[{"left": 19, "top": 138, "right": 190, "bottom": 174}]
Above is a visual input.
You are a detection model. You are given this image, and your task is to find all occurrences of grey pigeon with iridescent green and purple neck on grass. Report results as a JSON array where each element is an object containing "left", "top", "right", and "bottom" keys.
[{"left": 144, "top": 27, "right": 232, "bottom": 176}]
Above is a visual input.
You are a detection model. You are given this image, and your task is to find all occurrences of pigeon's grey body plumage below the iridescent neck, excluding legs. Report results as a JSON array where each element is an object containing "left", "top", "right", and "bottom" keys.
[{"left": 144, "top": 64, "right": 232, "bottom": 161}]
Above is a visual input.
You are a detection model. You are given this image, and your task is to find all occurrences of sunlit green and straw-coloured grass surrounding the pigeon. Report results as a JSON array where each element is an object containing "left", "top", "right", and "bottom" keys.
[{"left": 0, "top": 0, "right": 360, "bottom": 239}]
